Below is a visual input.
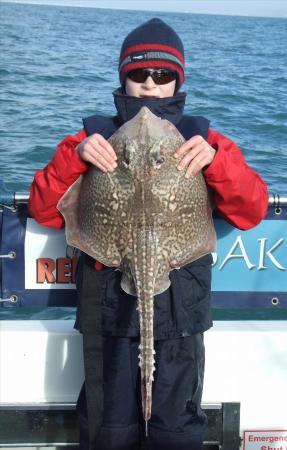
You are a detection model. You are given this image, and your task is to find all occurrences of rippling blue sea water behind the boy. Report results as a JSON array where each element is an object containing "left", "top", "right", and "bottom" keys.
[{"left": 0, "top": 3, "right": 287, "bottom": 195}]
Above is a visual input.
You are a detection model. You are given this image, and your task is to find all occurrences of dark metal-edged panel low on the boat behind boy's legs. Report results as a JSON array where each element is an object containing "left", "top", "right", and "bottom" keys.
[{"left": 0, "top": 402, "right": 240, "bottom": 450}]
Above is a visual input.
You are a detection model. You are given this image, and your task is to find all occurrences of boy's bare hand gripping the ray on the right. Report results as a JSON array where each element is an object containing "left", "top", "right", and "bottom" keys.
[{"left": 174, "top": 136, "right": 216, "bottom": 178}]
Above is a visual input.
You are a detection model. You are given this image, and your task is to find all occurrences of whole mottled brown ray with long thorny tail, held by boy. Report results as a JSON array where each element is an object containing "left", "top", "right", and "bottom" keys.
[{"left": 58, "top": 107, "right": 215, "bottom": 430}]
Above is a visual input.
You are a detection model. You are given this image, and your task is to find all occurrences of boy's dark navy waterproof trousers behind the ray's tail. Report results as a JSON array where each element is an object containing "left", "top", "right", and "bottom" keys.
[{"left": 77, "top": 333, "right": 207, "bottom": 450}]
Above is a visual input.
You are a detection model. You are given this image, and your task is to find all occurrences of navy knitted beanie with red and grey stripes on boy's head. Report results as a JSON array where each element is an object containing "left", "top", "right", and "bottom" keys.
[{"left": 119, "top": 19, "right": 184, "bottom": 88}]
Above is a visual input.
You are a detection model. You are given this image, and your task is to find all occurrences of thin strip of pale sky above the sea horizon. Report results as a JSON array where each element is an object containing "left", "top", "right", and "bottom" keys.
[{"left": 0, "top": 0, "right": 287, "bottom": 18}]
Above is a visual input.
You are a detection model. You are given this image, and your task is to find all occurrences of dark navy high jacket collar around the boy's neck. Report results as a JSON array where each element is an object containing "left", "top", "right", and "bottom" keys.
[{"left": 113, "top": 88, "right": 186, "bottom": 125}]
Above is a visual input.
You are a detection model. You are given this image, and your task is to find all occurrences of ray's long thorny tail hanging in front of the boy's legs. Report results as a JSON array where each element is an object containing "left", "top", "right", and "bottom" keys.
[{"left": 133, "top": 228, "right": 156, "bottom": 434}]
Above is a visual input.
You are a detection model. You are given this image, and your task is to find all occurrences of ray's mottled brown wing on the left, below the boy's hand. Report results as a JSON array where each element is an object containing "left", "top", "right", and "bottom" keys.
[{"left": 57, "top": 168, "right": 132, "bottom": 267}]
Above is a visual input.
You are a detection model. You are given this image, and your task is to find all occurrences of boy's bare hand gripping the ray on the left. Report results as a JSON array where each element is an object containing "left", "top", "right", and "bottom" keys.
[{"left": 76, "top": 133, "right": 117, "bottom": 172}]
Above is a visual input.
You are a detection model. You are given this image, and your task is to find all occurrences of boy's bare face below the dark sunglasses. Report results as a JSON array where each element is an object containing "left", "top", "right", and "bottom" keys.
[{"left": 125, "top": 71, "right": 176, "bottom": 98}]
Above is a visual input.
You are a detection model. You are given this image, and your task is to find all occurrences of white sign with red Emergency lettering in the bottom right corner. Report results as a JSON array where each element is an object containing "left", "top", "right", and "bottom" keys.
[{"left": 243, "top": 430, "right": 287, "bottom": 450}]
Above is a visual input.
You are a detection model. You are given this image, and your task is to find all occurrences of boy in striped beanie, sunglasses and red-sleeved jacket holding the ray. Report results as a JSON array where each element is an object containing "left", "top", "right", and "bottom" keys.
[{"left": 29, "top": 19, "right": 268, "bottom": 450}]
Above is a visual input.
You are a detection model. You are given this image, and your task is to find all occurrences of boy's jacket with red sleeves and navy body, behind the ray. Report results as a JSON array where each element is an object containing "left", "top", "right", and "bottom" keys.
[{"left": 29, "top": 90, "right": 268, "bottom": 339}]
